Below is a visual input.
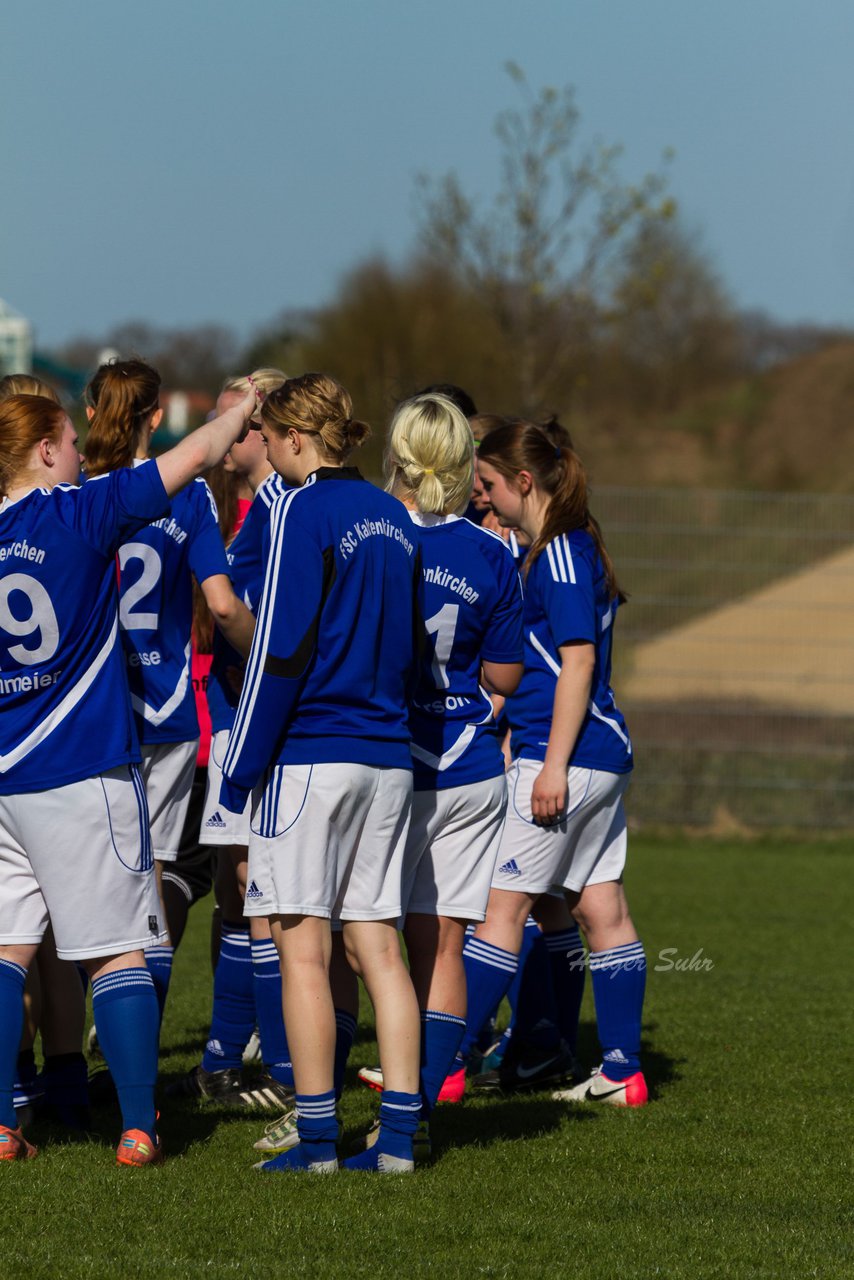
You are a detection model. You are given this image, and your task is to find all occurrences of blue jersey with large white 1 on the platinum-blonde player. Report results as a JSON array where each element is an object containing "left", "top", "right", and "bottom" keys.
[{"left": 410, "top": 512, "right": 524, "bottom": 791}]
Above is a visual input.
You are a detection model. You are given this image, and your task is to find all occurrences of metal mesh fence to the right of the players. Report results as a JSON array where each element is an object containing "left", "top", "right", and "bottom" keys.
[{"left": 593, "top": 488, "right": 854, "bottom": 831}]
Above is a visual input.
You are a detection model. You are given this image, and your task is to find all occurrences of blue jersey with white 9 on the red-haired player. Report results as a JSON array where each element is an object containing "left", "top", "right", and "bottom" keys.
[{"left": 0, "top": 462, "right": 169, "bottom": 795}]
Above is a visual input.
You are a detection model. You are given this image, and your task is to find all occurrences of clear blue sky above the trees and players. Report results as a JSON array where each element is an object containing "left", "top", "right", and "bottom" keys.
[{"left": 6, "top": 0, "right": 854, "bottom": 346}]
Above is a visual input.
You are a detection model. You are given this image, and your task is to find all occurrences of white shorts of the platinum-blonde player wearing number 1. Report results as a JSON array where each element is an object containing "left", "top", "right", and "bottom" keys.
[{"left": 403, "top": 773, "right": 507, "bottom": 920}]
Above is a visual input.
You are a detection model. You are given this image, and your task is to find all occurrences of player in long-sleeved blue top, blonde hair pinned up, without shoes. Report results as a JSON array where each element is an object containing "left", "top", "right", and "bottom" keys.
[{"left": 220, "top": 374, "right": 420, "bottom": 1172}]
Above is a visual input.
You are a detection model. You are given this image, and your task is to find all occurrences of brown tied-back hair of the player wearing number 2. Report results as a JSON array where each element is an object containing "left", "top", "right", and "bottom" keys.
[{"left": 85, "top": 360, "right": 160, "bottom": 476}]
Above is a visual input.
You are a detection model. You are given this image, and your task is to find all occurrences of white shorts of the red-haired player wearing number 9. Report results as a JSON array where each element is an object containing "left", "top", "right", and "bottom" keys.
[{"left": 0, "top": 764, "right": 166, "bottom": 960}]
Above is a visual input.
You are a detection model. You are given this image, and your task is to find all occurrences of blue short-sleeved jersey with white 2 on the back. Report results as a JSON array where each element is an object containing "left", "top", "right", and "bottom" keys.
[{"left": 119, "top": 480, "right": 228, "bottom": 744}]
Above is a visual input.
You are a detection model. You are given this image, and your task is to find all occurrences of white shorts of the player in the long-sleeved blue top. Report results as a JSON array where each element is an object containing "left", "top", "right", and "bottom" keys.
[{"left": 245, "top": 764, "right": 412, "bottom": 920}]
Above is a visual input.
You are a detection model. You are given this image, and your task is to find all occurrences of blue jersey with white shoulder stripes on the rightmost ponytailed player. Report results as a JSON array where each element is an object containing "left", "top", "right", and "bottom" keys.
[{"left": 506, "top": 530, "right": 632, "bottom": 773}]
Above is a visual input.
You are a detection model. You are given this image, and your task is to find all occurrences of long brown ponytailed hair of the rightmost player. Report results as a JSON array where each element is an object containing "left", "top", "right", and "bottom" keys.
[{"left": 478, "top": 422, "right": 626, "bottom": 602}]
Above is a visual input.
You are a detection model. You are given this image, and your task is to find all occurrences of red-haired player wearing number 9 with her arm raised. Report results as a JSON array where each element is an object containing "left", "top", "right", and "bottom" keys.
[{"left": 0, "top": 384, "right": 255, "bottom": 1165}]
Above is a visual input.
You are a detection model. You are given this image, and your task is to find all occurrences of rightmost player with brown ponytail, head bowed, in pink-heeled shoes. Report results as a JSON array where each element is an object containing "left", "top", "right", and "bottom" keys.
[{"left": 463, "top": 422, "right": 647, "bottom": 1106}]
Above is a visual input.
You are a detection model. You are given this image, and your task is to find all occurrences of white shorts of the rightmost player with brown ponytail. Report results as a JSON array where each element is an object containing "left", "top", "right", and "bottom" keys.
[{"left": 492, "top": 760, "right": 631, "bottom": 893}]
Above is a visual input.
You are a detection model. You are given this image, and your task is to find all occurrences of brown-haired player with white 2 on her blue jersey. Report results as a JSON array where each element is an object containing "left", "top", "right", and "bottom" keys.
[{"left": 86, "top": 360, "right": 255, "bottom": 1016}]
